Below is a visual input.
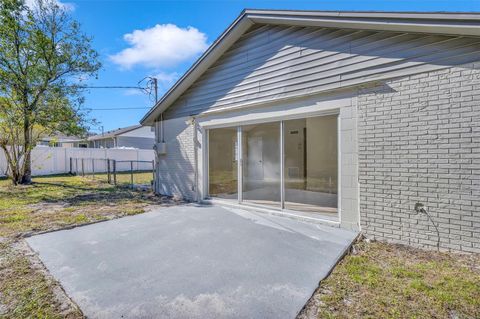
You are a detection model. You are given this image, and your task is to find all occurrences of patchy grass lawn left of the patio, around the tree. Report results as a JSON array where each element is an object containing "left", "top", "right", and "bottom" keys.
[{"left": 0, "top": 173, "right": 176, "bottom": 318}]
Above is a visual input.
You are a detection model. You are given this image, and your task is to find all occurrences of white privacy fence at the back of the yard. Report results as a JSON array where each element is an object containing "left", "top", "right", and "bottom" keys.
[{"left": 0, "top": 147, "right": 155, "bottom": 176}]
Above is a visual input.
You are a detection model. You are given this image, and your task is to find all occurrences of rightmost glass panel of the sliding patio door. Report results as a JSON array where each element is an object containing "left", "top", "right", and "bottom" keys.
[{"left": 284, "top": 115, "right": 338, "bottom": 217}]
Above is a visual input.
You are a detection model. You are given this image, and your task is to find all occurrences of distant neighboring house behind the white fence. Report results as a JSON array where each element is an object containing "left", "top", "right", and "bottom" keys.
[{"left": 87, "top": 125, "right": 155, "bottom": 150}]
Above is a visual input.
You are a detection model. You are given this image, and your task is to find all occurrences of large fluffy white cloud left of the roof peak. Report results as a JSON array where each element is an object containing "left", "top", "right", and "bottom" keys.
[{"left": 110, "top": 24, "right": 208, "bottom": 69}]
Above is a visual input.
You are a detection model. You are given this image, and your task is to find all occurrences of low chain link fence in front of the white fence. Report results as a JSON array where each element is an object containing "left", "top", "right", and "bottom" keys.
[{"left": 70, "top": 157, "right": 155, "bottom": 189}]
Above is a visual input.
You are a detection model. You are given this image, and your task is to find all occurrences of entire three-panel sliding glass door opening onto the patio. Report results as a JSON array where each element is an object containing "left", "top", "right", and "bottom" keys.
[{"left": 208, "top": 115, "right": 338, "bottom": 217}]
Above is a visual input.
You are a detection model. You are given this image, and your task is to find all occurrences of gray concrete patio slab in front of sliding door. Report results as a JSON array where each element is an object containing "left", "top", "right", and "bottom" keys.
[{"left": 27, "top": 205, "right": 356, "bottom": 319}]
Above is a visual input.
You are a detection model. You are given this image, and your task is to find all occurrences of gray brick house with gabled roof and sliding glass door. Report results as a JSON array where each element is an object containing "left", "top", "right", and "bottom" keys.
[{"left": 141, "top": 10, "right": 480, "bottom": 252}]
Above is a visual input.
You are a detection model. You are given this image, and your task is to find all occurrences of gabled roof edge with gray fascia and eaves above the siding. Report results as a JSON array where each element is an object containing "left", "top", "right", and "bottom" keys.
[{"left": 140, "top": 9, "right": 480, "bottom": 125}]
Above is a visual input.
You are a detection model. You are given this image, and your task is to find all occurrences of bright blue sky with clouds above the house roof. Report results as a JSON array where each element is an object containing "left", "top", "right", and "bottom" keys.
[{"left": 54, "top": 0, "right": 480, "bottom": 133}]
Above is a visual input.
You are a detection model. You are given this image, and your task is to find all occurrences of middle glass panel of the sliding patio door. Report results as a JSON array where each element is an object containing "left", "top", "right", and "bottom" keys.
[{"left": 242, "top": 122, "right": 280, "bottom": 207}]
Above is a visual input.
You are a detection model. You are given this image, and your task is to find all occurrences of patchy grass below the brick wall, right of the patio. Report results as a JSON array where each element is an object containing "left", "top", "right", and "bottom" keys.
[{"left": 315, "top": 242, "right": 480, "bottom": 318}]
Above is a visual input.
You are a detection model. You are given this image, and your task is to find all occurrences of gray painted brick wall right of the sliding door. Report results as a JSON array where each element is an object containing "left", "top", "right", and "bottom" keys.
[{"left": 358, "top": 63, "right": 480, "bottom": 253}]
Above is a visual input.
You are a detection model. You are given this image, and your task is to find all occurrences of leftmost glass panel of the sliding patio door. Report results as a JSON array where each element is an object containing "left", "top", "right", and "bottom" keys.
[{"left": 208, "top": 127, "right": 238, "bottom": 199}]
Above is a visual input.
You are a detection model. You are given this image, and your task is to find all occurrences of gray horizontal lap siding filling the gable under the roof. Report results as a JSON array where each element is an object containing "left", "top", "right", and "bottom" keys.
[{"left": 165, "top": 25, "right": 480, "bottom": 118}]
